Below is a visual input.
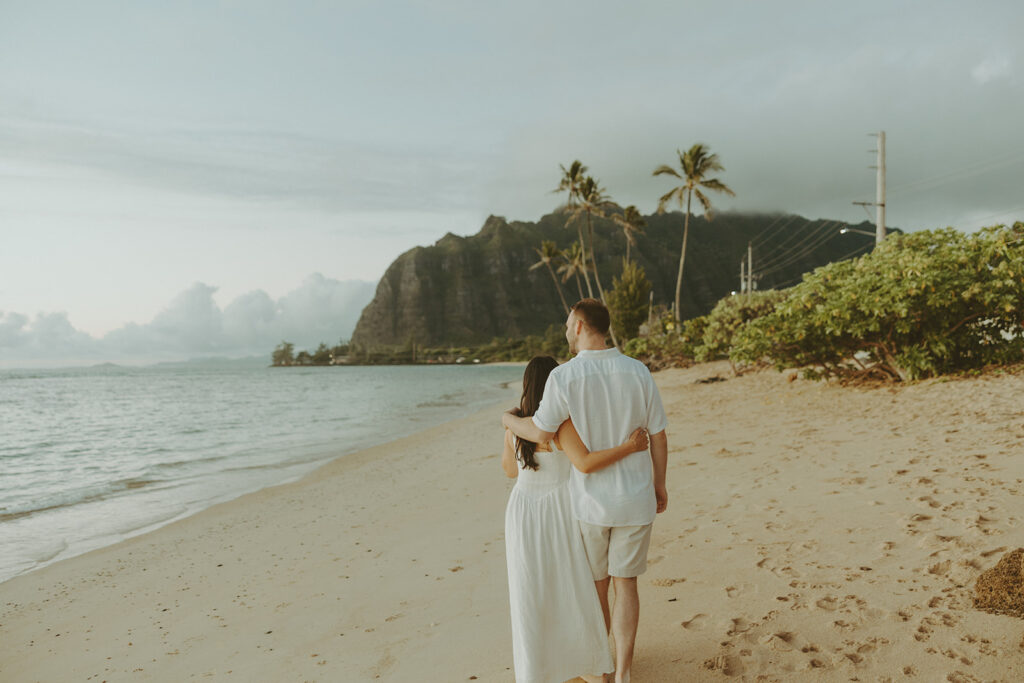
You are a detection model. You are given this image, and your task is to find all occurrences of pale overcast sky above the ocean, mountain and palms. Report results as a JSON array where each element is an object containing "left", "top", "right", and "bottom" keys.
[{"left": 0, "top": 0, "right": 1024, "bottom": 366}]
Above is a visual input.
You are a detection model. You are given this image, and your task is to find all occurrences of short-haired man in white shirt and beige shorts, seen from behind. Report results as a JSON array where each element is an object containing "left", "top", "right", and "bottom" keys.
[{"left": 502, "top": 299, "right": 669, "bottom": 683}]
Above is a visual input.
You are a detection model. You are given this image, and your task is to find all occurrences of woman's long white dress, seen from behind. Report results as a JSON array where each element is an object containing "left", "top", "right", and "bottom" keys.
[{"left": 505, "top": 451, "right": 614, "bottom": 683}]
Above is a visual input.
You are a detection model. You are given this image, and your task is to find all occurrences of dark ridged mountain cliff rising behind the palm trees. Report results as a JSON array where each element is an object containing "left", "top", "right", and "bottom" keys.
[{"left": 352, "top": 213, "right": 874, "bottom": 348}]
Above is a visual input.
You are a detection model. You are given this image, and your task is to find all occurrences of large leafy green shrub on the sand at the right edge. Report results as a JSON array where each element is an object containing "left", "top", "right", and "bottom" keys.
[{"left": 730, "top": 227, "right": 1024, "bottom": 380}]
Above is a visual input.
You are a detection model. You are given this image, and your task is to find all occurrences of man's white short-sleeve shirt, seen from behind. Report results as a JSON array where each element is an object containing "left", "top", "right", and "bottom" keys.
[{"left": 534, "top": 348, "right": 668, "bottom": 526}]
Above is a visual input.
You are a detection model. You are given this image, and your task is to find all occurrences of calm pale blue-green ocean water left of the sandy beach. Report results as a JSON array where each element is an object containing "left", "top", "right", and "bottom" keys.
[{"left": 0, "top": 365, "right": 522, "bottom": 582}]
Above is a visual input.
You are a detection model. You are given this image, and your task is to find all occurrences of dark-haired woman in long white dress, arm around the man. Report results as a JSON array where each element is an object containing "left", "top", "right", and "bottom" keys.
[{"left": 502, "top": 356, "right": 647, "bottom": 683}]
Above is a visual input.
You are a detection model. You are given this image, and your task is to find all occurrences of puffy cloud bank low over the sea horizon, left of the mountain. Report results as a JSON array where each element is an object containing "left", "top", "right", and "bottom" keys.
[{"left": 0, "top": 273, "right": 375, "bottom": 366}]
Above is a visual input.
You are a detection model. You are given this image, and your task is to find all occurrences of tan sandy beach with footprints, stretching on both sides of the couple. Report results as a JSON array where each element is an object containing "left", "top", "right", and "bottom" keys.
[{"left": 0, "top": 364, "right": 1024, "bottom": 683}]
